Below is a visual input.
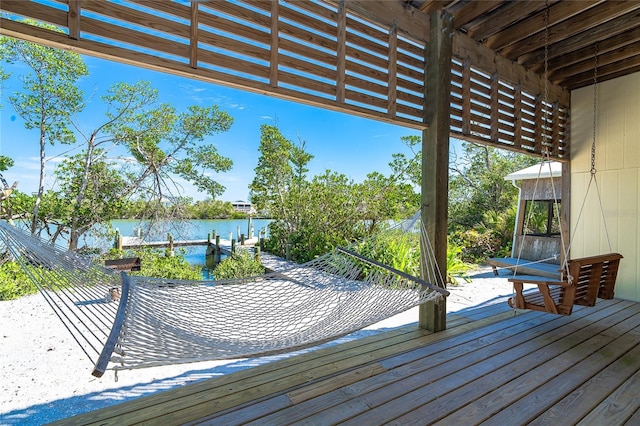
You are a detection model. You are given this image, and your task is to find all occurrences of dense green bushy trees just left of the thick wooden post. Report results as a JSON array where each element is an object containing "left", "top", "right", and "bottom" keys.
[{"left": 250, "top": 125, "right": 419, "bottom": 262}]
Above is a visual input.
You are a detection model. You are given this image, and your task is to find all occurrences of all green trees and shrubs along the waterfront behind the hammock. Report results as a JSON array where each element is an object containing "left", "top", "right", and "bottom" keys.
[{"left": 0, "top": 35, "right": 536, "bottom": 299}]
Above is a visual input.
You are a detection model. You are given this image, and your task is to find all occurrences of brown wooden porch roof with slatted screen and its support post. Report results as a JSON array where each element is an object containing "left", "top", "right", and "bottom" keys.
[{"left": 0, "top": 0, "right": 640, "bottom": 331}]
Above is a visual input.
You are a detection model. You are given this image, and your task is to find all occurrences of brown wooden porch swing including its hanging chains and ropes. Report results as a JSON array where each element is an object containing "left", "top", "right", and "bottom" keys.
[{"left": 508, "top": 36, "right": 622, "bottom": 315}]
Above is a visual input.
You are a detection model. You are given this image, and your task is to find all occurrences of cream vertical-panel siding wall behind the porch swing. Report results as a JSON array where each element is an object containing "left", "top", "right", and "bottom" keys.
[{"left": 570, "top": 73, "right": 640, "bottom": 302}]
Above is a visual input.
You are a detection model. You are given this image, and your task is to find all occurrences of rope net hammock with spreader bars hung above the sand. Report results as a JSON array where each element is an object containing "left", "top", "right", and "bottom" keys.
[{"left": 0, "top": 222, "right": 448, "bottom": 377}]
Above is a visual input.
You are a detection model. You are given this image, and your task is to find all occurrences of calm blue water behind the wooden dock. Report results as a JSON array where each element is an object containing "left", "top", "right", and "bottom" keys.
[{"left": 99, "top": 219, "right": 271, "bottom": 265}]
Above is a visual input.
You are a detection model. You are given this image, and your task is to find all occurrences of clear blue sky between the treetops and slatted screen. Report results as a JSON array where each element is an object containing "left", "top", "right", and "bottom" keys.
[{"left": 0, "top": 56, "right": 420, "bottom": 201}]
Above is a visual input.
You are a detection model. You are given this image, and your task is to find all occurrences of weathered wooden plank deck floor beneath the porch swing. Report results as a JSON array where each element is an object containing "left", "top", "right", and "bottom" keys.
[{"left": 55, "top": 299, "right": 640, "bottom": 425}]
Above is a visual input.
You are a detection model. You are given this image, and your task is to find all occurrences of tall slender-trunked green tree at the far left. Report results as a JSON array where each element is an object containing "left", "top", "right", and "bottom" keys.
[{"left": 0, "top": 26, "right": 88, "bottom": 233}]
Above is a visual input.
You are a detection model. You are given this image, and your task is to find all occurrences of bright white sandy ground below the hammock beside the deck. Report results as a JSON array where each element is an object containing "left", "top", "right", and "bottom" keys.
[{"left": 0, "top": 268, "right": 512, "bottom": 425}]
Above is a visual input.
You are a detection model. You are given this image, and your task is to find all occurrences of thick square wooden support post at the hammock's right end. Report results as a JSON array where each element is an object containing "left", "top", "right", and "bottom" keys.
[{"left": 419, "top": 11, "right": 454, "bottom": 332}]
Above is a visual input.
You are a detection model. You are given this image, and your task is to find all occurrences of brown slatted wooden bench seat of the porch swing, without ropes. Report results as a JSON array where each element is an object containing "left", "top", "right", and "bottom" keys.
[{"left": 508, "top": 253, "right": 622, "bottom": 315}]
